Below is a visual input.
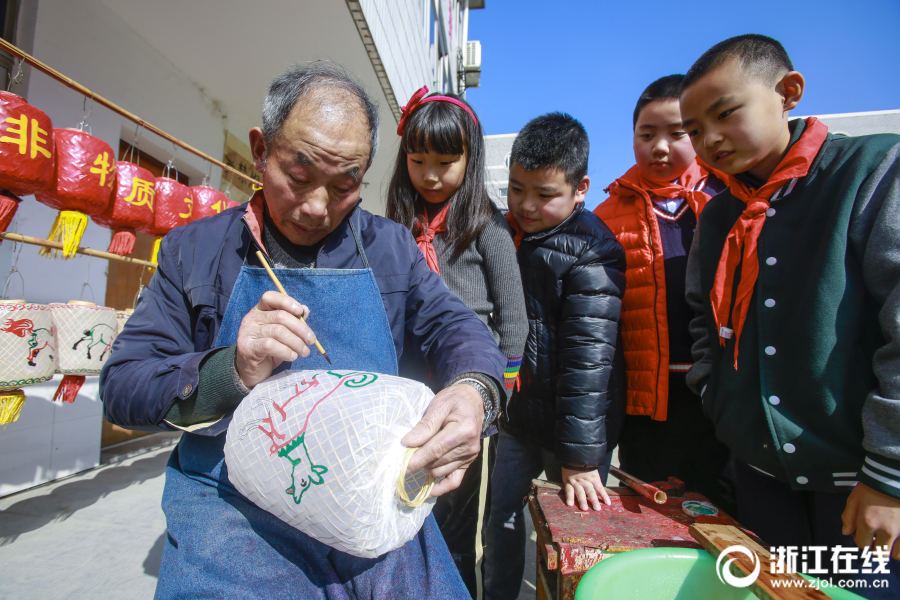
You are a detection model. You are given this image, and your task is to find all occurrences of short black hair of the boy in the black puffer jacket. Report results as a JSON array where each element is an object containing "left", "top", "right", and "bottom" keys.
[{"left": 509, "top": 112, "right": 590, "bottom": 190}]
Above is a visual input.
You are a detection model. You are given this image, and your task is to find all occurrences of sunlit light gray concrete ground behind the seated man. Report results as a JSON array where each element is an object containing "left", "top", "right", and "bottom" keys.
[{"left": 0, "top": 446, "right": 564, "bottom": 600}]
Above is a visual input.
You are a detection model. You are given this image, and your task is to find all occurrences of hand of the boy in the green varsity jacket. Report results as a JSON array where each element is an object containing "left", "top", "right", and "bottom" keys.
[{"left": 841, "top": 483, "right": 900, "bottom": 560}]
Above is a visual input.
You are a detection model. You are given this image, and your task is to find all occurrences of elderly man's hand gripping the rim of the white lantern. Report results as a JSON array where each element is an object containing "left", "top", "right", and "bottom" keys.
[{"left": 402, "top": 383, "right": 484, "bottom": 497}]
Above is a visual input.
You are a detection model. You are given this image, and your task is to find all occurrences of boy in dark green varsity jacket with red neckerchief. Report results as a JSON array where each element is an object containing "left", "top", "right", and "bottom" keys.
[{"left": 681, "top": 35, "right": 900, "bottom": 598}]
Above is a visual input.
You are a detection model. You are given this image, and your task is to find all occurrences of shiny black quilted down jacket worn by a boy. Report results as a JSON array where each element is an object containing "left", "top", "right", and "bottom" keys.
[{"left": 502, "top": 204, "right": 625, "bottom": 469}]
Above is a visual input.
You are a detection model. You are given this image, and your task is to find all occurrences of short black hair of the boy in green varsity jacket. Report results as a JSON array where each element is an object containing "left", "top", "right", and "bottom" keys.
[{"left": 681, "top": 33, "right": 794, "bottom": 90}]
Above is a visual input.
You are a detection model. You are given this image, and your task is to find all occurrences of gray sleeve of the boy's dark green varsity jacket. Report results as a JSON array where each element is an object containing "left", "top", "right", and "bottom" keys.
[{"left": 850, "top": 144, "right": 900, "bottom": 488}]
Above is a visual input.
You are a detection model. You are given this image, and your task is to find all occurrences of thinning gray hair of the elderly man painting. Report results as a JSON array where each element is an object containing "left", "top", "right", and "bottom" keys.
[{"left": 262, "top": 61, "right": 380, "bottom": 169}]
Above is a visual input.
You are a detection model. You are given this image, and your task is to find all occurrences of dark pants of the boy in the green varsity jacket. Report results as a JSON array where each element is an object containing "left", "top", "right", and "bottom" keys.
[{"left": 735, "top": 461, "right": 900, "bottom": 599}]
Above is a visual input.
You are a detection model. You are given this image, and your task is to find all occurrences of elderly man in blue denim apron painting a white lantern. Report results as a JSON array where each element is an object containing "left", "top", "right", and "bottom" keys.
[{"left": 101, "top": 63, "right": 506, "bottom": 599}]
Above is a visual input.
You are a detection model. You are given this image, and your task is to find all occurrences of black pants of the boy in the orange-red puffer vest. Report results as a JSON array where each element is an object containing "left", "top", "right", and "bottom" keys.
[{"left": 619, "top": 373, "right": 736, "bottom": 515}]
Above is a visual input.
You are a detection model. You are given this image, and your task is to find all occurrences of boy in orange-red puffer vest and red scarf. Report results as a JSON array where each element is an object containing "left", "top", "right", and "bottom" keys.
[{"left": 594, "top": 75, "right": 734, "bottom": 512}]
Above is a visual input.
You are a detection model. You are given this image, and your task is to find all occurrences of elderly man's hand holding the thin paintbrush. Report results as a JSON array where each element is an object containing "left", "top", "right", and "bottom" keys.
[{"left": 235, "top": 292, "right": 316, "bottom": 388}]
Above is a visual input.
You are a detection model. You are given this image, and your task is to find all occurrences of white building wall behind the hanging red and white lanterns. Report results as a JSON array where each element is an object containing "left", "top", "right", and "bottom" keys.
[{"left": 0, "top": 0, "right": 239, "bottom": 495}]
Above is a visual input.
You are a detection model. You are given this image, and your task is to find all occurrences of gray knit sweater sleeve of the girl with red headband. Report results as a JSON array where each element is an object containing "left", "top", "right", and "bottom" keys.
[{"left": 477, "top": 212, "right": 528, "bottom": 359}]
